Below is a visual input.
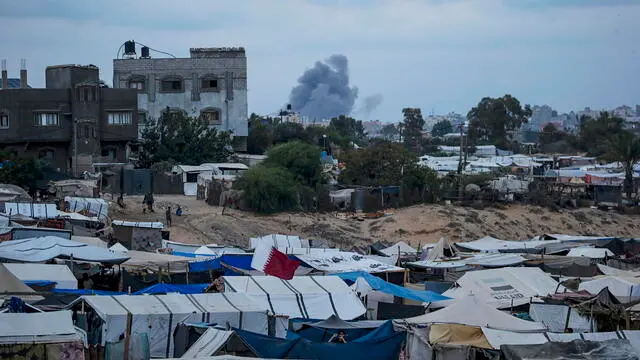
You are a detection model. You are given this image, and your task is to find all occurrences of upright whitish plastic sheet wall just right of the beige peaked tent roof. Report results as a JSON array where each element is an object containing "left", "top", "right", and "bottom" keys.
[{"left": 529, "top": 303, "right": 596, "bottom": 333}]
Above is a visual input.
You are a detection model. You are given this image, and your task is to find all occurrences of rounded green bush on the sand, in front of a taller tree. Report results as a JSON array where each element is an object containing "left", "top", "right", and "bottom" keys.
[{"left": 233, "top": 165, "right": 301, "bottom": 213}]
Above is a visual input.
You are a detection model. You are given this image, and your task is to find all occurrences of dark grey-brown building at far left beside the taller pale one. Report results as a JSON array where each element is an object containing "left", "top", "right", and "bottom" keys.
[{"left": 0, "top": 65, "right": 138, "bottom": 174}]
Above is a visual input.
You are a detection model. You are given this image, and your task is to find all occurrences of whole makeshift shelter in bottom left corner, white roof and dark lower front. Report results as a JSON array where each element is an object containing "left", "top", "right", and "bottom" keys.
[{"left": 0, "top": 311, "right": 84, "bottom": 360}]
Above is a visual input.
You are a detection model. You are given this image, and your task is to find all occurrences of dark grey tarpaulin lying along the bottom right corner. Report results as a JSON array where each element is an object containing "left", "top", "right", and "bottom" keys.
[{"left": 500, "top": 339, "right": 640, "bottom": 360}]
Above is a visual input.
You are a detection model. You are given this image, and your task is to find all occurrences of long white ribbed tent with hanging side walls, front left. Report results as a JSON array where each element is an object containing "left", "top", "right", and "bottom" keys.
[{"left": 82, "top": 294, "right": 268, "bottom": 357}]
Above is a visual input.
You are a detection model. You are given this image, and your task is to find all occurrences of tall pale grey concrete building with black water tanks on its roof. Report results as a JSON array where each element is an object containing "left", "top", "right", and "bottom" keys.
[{"left": 113, "top": 44, "right": 249, "bottom": 150}]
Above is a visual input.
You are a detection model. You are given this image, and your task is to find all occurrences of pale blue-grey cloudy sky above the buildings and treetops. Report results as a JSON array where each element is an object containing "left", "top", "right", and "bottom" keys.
[{"left": 0, "top": 0, "right": 640, "bottom": 121}]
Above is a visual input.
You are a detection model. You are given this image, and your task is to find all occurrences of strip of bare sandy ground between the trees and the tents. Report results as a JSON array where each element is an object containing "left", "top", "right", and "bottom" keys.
[{"left": 109, "top": 195, "right": 640, "bottom": 251}]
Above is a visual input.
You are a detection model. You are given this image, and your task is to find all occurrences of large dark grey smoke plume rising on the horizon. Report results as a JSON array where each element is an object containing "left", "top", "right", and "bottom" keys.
[{"left": 289, "top": 54, "right": 360, "bottom": 119}]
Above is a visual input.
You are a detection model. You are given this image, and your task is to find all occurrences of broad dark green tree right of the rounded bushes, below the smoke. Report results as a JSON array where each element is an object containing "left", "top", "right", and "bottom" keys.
[{"left": 340, "top": 141, "right": 418, "bottom": 186}]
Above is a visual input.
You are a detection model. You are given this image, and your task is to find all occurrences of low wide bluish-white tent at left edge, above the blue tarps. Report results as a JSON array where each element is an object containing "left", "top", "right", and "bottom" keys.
[{"left": 0, "top": 236, "right": 129, "bottom": 264}]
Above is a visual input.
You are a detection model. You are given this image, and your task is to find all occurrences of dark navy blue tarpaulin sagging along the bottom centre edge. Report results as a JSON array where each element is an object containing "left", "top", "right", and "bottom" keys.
[{"left": 234, "top": 329, "right": 405, "bottom": 360}]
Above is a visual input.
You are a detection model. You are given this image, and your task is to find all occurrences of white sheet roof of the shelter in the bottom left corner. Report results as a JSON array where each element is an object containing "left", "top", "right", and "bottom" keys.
[{"left": 0, "top": 311, "right": 82, "bottom": 344}]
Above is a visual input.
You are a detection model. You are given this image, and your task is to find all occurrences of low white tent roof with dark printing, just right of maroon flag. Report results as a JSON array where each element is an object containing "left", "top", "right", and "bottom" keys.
[{"left": 297, "top": 251, "right": 404, "bottom": 273}]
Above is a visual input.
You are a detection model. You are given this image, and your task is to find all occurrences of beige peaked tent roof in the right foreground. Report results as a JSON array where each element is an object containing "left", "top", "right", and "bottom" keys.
[{"left": 405, "top": 295, "right": 546, "bottom": 332}]
